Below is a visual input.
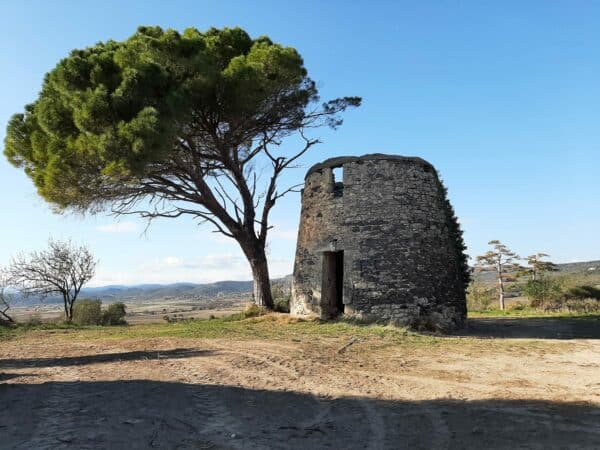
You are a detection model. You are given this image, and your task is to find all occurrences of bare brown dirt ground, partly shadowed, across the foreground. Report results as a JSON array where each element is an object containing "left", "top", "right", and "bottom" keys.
[{"left": 0, "top": 319, "right": 600, "bottom": 449}]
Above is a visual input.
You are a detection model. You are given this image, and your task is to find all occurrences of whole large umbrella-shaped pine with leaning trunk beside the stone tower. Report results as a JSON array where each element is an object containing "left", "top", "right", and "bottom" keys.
[{"left": 4, "top": 27, "right": 361, "bottom": 307}]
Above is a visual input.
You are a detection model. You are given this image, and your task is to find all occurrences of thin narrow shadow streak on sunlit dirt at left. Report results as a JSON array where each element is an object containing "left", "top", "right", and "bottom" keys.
[{"left": 0, "top": 348, "right": 214, "bottom": 369}]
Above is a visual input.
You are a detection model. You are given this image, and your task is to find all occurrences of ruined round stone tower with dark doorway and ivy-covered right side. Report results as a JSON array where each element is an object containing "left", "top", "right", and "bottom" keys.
[{"left": 290, "top": 154, "right": 469, "bottom": 331}]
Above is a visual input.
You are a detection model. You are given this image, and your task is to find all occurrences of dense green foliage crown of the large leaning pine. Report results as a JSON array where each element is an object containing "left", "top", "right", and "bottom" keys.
[{"left": 4, "top": 27, "right": 360, "bottom": 211}]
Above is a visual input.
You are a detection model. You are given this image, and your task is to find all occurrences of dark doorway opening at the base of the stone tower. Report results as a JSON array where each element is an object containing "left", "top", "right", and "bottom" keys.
[{"left": 321, "top": 251, "right": 344, "bottom": 318}]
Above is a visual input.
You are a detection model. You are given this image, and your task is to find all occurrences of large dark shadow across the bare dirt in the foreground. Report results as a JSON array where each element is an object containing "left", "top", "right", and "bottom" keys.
[{"left": 0, "top": 380, "right": 600, "bottom": 450}]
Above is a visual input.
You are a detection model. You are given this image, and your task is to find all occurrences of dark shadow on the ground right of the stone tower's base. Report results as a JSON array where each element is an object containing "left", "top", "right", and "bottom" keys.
[{"left": 455, "top": 317, "right": 600, "bottom": 339}]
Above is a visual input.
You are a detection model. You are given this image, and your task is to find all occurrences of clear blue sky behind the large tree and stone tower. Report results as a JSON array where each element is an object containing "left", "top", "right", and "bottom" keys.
[{"left": 0, "top": 0, "right": 600, "bottom": 285}]
